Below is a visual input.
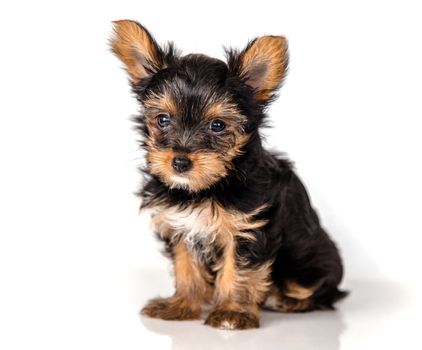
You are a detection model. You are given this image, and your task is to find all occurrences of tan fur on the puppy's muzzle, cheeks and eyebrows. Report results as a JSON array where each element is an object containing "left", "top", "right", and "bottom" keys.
[{"left": 140, "top": 83, "right": 250, "bottom": 192}]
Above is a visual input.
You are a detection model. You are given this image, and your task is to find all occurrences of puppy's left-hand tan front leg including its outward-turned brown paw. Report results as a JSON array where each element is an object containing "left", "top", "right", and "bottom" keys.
[{"left": 141, "top": 242, "right": 210, "bottom": 320}]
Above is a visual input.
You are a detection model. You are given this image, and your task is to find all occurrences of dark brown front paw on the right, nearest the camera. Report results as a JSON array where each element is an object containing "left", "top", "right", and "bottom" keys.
[{"left": 205, "top": 310, "right": 259, "bottom": 329}]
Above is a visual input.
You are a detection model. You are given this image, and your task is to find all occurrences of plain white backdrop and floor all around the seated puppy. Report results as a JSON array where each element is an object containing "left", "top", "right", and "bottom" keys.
[{"left": 0, "top": 0, "right": 422, "bottom": 350}]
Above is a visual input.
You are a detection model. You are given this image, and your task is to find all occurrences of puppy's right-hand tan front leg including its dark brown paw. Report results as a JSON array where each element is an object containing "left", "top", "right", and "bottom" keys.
[{"left": 205, "top": 239, "right": 271, "bottom": 329}]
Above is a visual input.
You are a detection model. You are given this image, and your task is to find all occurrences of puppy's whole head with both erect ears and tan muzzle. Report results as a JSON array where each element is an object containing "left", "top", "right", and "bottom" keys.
[{"left": 111, "top": 20, "right": 287, "bottom": 192}]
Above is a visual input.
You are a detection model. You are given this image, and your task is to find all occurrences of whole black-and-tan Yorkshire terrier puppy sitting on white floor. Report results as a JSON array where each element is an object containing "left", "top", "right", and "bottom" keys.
[{"left": 111, "top": 20, "right": 346, "bottom": 329}]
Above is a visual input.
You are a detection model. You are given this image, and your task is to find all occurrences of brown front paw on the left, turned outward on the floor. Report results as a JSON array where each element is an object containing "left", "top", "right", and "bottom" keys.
[{"left": 141, "top": 297, "right": 201, "bottom": 320}]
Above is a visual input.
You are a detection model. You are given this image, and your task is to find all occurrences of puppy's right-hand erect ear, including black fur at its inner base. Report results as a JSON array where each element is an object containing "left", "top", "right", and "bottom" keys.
[{"left": 229, "top": 36, "right": 288, "bottom": 101}]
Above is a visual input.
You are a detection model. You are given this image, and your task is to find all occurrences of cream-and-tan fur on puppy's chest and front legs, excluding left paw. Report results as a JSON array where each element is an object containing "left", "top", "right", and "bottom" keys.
[{"left": 145, "top": 200, "right": 272, "bottom": 328}]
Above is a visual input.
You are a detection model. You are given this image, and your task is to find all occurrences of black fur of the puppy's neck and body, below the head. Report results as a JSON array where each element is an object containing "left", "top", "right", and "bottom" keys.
[{"left": 139, "top": 144, "right": 347, "bottom": 309}]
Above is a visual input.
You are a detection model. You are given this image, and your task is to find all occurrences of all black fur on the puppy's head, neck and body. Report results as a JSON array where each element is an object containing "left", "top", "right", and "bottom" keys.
[{"left": 112, "top": 20, "right": 345, "bottom": 309}]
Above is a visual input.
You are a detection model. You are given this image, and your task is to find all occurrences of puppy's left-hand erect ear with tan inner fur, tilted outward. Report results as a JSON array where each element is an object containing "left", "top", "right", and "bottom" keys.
[{"left": 110, "top": 20, "right": 164, "bottom": 84}]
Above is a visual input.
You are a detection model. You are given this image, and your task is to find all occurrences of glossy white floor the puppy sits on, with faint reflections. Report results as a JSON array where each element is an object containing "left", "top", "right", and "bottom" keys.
[{"left": 0, "top": 268, "right": 422, "bottom": 350}]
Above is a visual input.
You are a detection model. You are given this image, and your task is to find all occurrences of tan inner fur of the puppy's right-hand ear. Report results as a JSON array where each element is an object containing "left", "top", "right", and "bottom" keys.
[{"left": 242, "top": 36, "right": 287, "bottom": 100}]
